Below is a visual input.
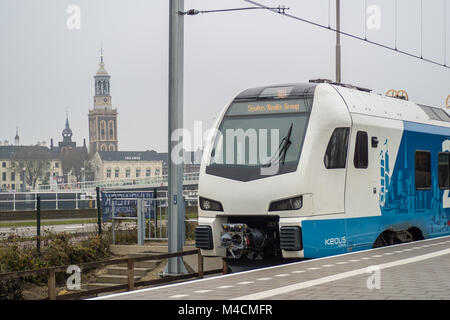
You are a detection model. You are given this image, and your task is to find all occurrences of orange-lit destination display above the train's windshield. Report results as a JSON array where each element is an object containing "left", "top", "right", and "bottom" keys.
[{"left": 227, "top": 99, "right": 308, "bottom": 116}]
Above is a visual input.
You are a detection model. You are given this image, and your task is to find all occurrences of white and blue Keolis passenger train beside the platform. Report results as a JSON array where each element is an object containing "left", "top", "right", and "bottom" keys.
[{"left": 196, "top": 81, "right": 450, "bottom": 259}]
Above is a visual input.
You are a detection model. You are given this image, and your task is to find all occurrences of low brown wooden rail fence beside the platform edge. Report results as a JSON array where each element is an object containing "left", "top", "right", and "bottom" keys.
[{"left": 0, "top": 249, "right": 228, "bottom": 300}]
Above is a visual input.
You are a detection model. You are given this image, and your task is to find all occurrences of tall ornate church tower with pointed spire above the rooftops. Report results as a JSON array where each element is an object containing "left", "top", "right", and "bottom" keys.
[{"left": 89, "top": 49, "right": 118, "bottom": 154}]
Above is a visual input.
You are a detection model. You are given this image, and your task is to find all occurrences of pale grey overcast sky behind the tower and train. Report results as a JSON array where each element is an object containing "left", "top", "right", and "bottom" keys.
[{"left": 0, "top": 0, "right": 450, "bottom": 152}]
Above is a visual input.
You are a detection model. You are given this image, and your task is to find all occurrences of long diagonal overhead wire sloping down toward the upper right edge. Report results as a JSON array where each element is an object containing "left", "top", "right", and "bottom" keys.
[{"left": 244, "top": 0, "right": 450, "bottom": 69}]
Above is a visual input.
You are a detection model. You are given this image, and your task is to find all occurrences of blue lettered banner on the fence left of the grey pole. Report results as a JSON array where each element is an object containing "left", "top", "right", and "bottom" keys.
[{"left": 101, "top": 191, "right": 155, "bottom": 221}]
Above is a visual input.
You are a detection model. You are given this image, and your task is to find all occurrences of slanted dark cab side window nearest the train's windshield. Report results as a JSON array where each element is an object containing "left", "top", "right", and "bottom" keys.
[{"left": 323, "top": 128, "right": 350, "bottom": 169}]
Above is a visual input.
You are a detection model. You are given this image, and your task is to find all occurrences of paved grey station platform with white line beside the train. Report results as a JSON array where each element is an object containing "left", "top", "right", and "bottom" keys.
[{"left": 94, "top": 236, "right": 450, "bottom": 300}]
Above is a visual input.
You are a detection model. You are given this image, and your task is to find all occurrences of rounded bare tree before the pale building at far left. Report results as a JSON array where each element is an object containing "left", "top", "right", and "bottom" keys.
[{"left": 11, "top": 146, "right": 51, "bottom": 189}]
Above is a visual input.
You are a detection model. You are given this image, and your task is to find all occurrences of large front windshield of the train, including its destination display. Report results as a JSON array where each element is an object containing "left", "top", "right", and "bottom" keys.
[{"left": 206, "top": 98, "right": 312, "bottom": 181}]
